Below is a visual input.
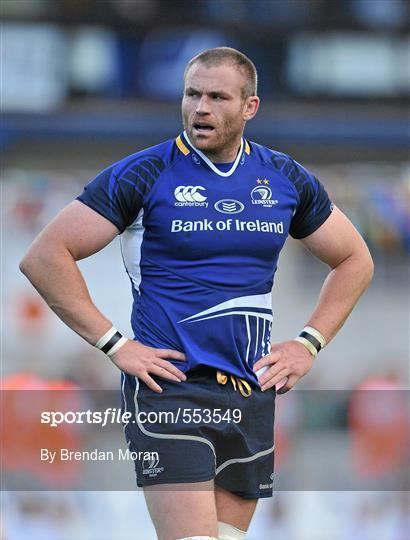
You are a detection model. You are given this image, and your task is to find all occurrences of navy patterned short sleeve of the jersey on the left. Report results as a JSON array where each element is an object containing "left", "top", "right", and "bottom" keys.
[{"left": 77, "top": 156, "right": 163, "bottom": 233}]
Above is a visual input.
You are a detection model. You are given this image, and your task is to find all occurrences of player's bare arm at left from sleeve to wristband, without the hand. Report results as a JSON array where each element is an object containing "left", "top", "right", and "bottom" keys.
[{"left": 20, "top": 201, "right": 118, "bottom": 344}]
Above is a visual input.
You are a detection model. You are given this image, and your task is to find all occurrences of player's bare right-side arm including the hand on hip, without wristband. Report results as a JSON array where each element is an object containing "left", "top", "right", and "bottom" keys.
[{"left": 254, "top": 208, "right": 373, "bottom": 393}]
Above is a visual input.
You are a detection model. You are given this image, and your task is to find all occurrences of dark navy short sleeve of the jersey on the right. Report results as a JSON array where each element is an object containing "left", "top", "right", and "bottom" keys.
[{"left": 287, "top": 158, "right": 333, "bottom": 239}]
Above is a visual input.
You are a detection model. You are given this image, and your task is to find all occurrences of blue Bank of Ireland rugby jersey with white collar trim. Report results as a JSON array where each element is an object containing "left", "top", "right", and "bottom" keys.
[{"left": 78, "top": 133, "right": 333, "bottom": 383}]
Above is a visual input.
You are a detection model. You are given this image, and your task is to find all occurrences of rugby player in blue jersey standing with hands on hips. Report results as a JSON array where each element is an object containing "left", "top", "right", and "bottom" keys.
[{"left": 21, "top": 47, "right": 373, "bottom": 540}]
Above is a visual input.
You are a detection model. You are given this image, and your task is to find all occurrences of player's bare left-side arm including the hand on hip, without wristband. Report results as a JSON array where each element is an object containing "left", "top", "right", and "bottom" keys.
[{"left": 20, "top": 201, "right": 186, "bottom": 392}]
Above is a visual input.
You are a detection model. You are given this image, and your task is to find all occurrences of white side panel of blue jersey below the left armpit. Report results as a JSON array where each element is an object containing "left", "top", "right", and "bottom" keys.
[{"left": 120, "top": 209, "right": 145, "bottom": 292}]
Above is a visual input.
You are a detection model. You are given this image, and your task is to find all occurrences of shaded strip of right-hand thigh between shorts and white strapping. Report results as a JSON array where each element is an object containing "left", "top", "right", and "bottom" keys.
[{"left": 215, "top": 486, "right": 258, "bottom": 531}]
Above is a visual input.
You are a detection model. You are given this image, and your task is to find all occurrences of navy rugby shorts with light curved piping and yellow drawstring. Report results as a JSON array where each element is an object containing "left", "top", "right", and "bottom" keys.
[{"left": 122, "top": 366, "right": 276, "bottom": 499}]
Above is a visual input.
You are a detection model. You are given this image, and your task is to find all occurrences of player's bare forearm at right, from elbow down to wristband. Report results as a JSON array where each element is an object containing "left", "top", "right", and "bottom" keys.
[{"left": 307, "top": 248, "right": 373, "bottom": 342}]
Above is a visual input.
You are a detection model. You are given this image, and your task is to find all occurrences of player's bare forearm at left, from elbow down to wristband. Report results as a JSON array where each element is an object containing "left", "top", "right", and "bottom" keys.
[{"left": 20, "top": 247, "right": 112, "bottom": 345}]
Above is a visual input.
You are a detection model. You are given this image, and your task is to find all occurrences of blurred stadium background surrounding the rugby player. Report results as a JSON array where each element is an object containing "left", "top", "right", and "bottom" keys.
[{"left": 0, "top": 0, "right": 410, "bottom": 540}]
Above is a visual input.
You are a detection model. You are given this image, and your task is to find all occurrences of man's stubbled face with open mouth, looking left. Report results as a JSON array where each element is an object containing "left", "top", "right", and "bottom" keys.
[{"left": 182, "top": 62, "right": 259, "bottom": 161}]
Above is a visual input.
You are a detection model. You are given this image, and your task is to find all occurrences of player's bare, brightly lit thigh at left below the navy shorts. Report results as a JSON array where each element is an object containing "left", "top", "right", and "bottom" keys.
[{"left": 144, "top": 481, "right": 218, "bottom": 540}]
